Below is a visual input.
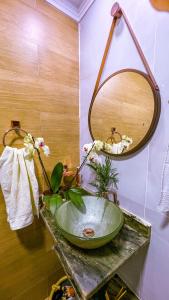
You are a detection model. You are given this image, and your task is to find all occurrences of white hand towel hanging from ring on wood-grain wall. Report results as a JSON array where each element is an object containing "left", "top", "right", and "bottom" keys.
[{"left": 0, "top": 146, "right": 39, "bottom": 230}]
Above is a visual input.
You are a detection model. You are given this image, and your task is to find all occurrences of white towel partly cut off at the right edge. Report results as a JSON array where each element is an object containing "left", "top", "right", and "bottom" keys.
[{"left": 159, "top": 147, "right": 169, "bottom": 212}]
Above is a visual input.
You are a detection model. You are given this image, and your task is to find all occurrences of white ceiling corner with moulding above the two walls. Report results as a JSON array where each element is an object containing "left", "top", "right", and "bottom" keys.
[{"left": 46, "top": 0, "right": 94, "bottom": 22}]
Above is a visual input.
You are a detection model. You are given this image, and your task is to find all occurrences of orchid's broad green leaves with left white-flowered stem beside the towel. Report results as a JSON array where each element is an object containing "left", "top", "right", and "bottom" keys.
[{"left": 24, "top": 134, "right": 88, "bottom": 215}]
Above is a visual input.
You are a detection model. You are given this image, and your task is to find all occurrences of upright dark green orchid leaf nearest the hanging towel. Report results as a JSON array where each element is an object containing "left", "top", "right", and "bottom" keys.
[{"left": 51, "top": 162, "right": 63, "bottom": 193}]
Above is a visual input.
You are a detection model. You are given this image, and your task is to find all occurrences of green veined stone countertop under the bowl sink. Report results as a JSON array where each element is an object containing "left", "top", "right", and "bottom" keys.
[{"left": 41, "top": 208, "right": 151, "bottom": 300}]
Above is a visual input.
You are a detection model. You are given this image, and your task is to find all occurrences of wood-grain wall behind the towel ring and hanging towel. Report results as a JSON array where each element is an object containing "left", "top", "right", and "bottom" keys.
[{"left": 0, "top": 0, "right": 79, "bottom": 300}]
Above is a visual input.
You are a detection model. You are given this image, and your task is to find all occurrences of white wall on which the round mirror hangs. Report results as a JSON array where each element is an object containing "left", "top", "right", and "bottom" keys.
[{"left": 80, "top": 0, "right": 169, "bottom": 300}]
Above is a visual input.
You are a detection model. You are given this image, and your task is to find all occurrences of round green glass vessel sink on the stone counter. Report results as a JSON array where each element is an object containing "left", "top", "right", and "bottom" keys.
[{"left": 55, "top": 196, "right": 123, "bottom": 249}]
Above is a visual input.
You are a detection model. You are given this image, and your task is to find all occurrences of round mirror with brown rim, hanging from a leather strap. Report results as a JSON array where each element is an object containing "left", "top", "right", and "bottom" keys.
[{"left": 89, "top": 69, "right": 160, "bottom": 156}]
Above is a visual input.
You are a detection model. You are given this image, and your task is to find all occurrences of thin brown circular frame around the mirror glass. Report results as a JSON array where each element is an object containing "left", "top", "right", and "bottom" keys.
[{"left": 88, "top": 69, "right": 161, "bottom": 158}]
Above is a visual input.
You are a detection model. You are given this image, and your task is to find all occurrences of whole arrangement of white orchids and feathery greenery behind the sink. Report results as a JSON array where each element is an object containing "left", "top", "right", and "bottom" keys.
[{"left": 24, "top": 134, "right": 129, "bottom": 215}]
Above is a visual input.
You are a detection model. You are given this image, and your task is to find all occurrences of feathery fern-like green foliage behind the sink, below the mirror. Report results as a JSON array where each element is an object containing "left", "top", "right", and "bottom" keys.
[{"left": 87, "top": 157, "right": 119, "bottom": 196}]
